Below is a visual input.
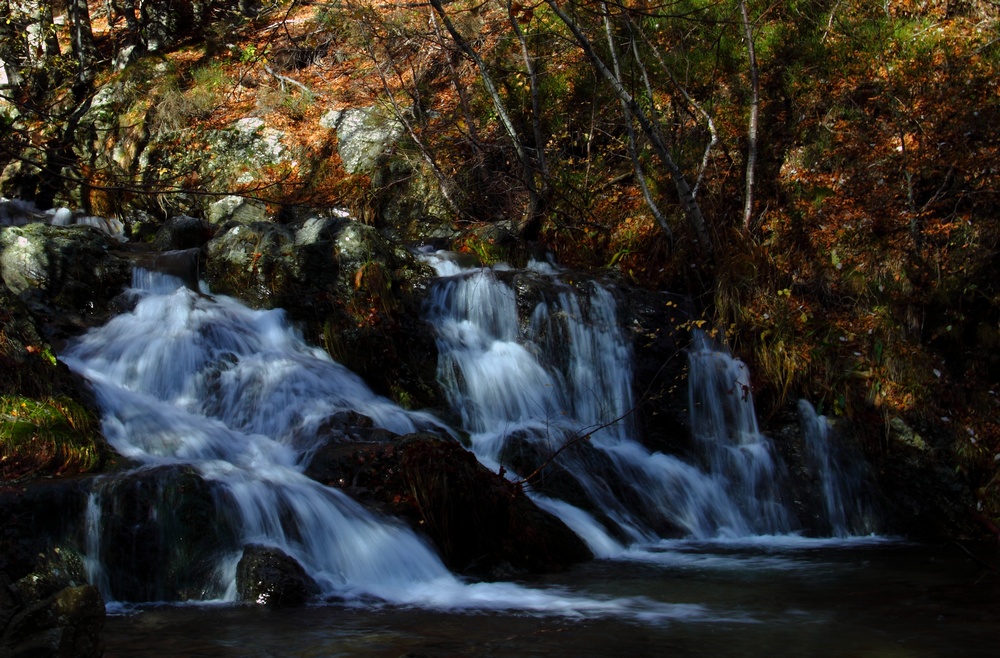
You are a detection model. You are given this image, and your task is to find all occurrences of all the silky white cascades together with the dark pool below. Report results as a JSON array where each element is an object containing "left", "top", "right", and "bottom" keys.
[{"left": 63, "top": 262, "right": 1000, "bottom": 658}]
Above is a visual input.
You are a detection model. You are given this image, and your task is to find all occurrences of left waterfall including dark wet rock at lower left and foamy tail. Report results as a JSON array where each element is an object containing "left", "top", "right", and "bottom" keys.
[{"left": 61, "top": 271, "right": 720, "bottom": 620}]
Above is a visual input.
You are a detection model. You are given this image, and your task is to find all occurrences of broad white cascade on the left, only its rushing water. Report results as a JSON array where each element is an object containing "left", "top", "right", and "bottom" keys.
[{"left": 63, "top": 273, "right": 452, "bottom": 599}]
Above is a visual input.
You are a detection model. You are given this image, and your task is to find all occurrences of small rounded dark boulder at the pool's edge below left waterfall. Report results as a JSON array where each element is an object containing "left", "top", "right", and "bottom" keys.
[{"left": 236, "top": 544, "right": 319, "bottom": 607}]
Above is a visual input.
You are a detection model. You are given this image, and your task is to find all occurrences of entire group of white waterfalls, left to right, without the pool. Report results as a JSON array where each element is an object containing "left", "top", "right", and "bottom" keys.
[{"left": 61, "top": 257, "right": 880, "bottom": 616}]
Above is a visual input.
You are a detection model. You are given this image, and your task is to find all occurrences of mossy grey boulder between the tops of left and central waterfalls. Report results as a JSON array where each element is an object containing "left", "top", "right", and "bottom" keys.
[{"left": 205, "top": 213, "right": 440, "bottom": 407}]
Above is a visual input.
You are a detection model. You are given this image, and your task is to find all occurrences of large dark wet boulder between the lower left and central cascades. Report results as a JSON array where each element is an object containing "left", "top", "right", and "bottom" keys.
[{"left": 307, "top": 435, "right": 592, "bottom": 578}]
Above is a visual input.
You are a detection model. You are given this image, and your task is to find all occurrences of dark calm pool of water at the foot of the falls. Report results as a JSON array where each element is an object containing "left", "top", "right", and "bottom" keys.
[{"left": 105, "top": 542, "right": 1000, "bottom": 658}]
